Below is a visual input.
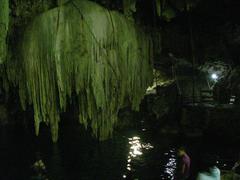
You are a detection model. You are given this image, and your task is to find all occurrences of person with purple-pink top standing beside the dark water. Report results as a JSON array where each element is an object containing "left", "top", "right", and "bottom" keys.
[{"left": 178, "top": 147, "right": 191, "bottom": 180}]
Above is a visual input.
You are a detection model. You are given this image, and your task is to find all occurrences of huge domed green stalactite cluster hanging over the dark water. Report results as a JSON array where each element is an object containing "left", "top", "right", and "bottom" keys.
[{"left": 8, "top": 0, "right": 153, "bottom": 141}]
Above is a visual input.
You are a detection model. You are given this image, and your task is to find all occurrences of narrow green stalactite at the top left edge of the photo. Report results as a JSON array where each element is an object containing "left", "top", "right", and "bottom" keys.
[{"left": 0, "top": 0, "right": 9, "bottom": 64}]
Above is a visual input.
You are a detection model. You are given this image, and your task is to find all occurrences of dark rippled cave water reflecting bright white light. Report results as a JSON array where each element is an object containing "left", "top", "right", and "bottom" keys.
[{"left": 0, "top": 114, "right": 239, "bottom": 180}]
